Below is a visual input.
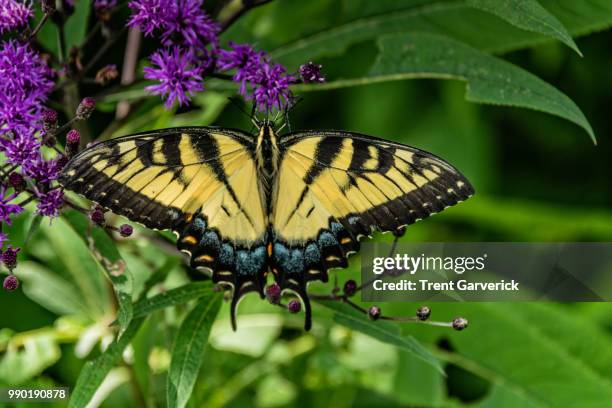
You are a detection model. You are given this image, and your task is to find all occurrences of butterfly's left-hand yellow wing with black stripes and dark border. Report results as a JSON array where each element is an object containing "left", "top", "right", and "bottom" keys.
[{"left": 60, "top": 127, "right": 267, "bottom": 278}]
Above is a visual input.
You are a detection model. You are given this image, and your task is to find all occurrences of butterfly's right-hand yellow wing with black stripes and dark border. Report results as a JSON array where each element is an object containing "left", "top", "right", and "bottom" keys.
[{"left": 271, "top": 132, "right": 474, "bottom": 274}]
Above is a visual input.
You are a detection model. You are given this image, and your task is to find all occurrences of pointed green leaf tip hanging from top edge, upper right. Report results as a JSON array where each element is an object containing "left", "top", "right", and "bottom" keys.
[{"left": 467, "top": 0, "right": 582, "bottom": 56}]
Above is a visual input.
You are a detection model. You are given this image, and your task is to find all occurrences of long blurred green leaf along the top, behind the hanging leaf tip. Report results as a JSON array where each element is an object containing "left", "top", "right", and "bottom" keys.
[{"left": 270, "top": 0, "right": 612, "bottom": 67}]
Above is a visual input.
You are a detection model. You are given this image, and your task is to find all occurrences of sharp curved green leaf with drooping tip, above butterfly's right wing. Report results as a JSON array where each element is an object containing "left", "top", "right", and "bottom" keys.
[{"left": 297, "top": 33, "right": 596, "bottom": 142}]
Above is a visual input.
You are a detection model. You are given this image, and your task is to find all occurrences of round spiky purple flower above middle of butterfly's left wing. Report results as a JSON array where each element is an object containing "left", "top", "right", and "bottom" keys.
[{"left": 144, "top": 46, "right": 204, "bottom": 109}]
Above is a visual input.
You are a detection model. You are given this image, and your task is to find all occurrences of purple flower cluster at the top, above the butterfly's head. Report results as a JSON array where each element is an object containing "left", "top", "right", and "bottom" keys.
[{"left": 128, "top": 0, "right": 325, "bottom": 112}]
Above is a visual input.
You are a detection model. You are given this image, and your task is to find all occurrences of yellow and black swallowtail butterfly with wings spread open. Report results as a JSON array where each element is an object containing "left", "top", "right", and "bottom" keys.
[{"left": 59, "top": 121, "right": 474, "bottom": 330}]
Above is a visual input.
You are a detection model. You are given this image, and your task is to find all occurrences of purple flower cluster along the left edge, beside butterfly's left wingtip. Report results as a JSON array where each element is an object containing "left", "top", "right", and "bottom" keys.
[{"left": 0, "top": 36, "right": 63, "bottom": 262}]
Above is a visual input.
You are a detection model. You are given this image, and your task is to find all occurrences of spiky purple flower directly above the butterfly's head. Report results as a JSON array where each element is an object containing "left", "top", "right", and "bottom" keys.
[{"left": 252, "top": 63, "right": 295, "bottom": 111}]
